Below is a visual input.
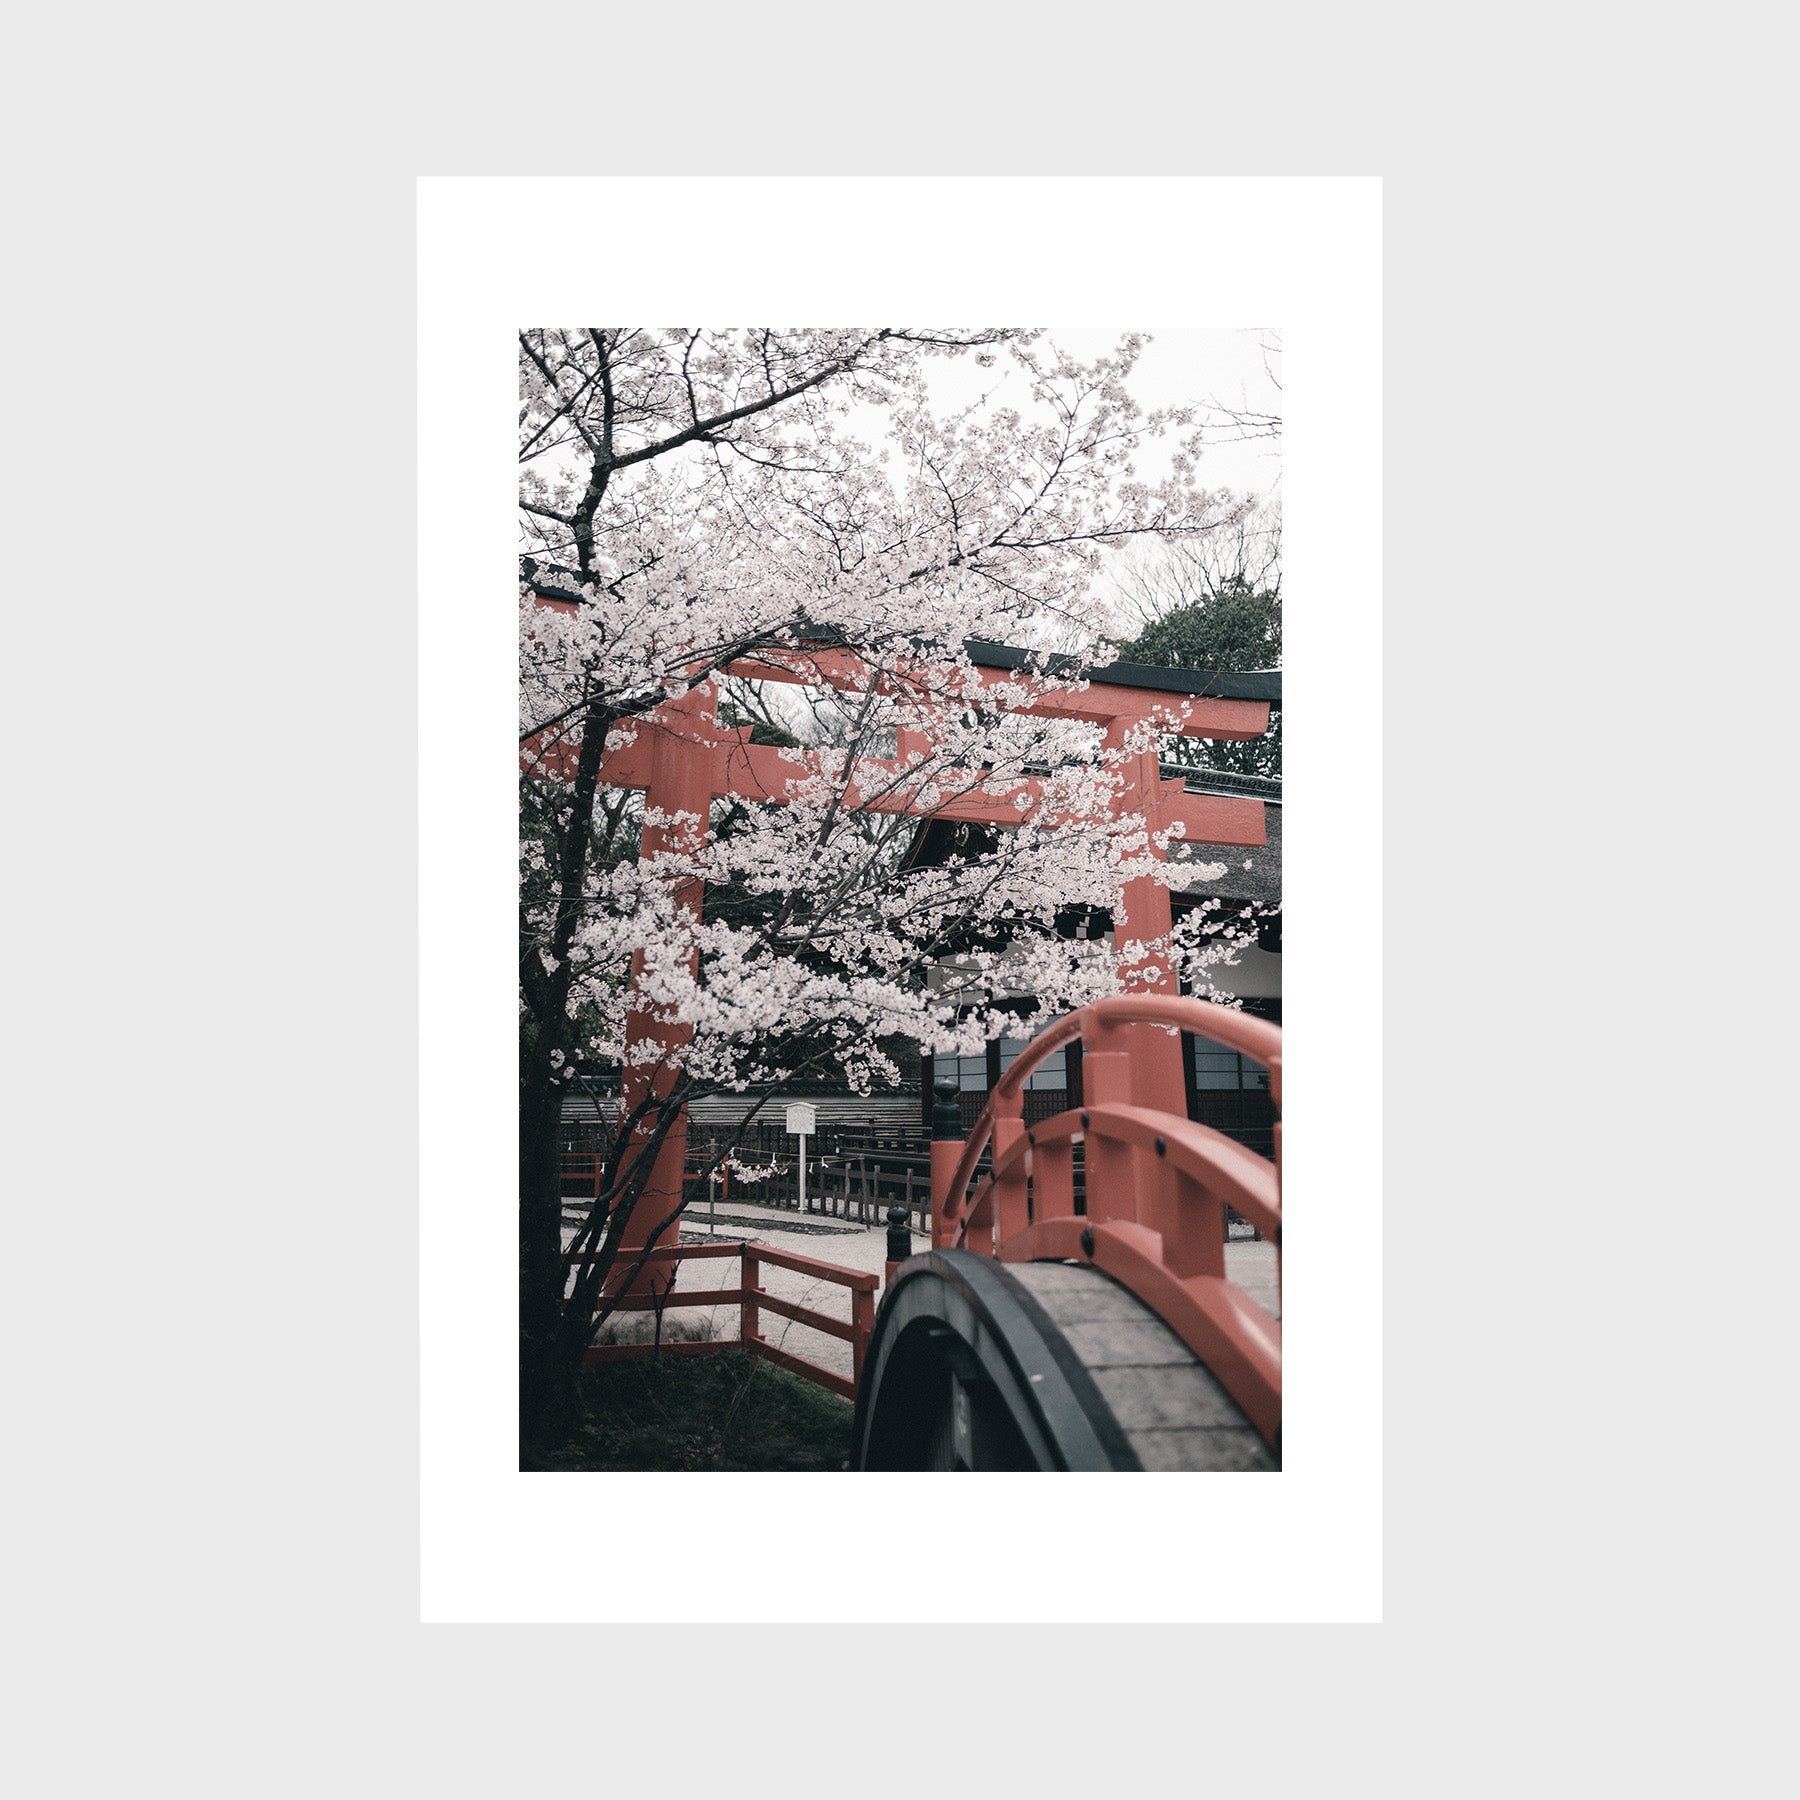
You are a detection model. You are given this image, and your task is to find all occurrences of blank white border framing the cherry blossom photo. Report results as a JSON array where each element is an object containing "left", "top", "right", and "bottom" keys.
[{"left": 418, "top": 176, "right": 1382, "bottom": 1624}]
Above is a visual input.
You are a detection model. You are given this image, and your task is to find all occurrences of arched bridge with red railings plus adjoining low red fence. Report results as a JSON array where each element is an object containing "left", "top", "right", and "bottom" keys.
[{"left": 572, "top": 994, "right": 1282, "bottom": 1469}]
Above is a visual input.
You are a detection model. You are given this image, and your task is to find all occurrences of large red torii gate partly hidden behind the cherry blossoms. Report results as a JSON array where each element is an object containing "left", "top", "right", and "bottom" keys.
[{"left": 524, "top": 650, "right": 1269, "bottom": 1288}]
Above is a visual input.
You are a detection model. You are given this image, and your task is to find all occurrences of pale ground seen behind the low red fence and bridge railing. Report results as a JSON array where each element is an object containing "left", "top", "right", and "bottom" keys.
[{"left": 565, "top": 1201, "right": 1280, "bottom": 1381}]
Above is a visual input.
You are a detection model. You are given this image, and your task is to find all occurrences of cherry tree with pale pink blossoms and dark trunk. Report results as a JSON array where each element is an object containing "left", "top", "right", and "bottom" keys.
[{"left": 518, "top": 326, "right": 1267, "bottom": 1433}]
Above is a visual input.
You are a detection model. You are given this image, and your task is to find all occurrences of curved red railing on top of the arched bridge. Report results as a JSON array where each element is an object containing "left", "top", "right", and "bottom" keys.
[{"left": 932, "top": 994, "right": 1282, "bottom": 1442}]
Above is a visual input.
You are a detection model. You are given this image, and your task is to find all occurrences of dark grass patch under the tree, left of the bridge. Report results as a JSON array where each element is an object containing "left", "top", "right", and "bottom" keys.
[{"left": 520, "top": 1350, "right": 855, "bottom": 1471}]
